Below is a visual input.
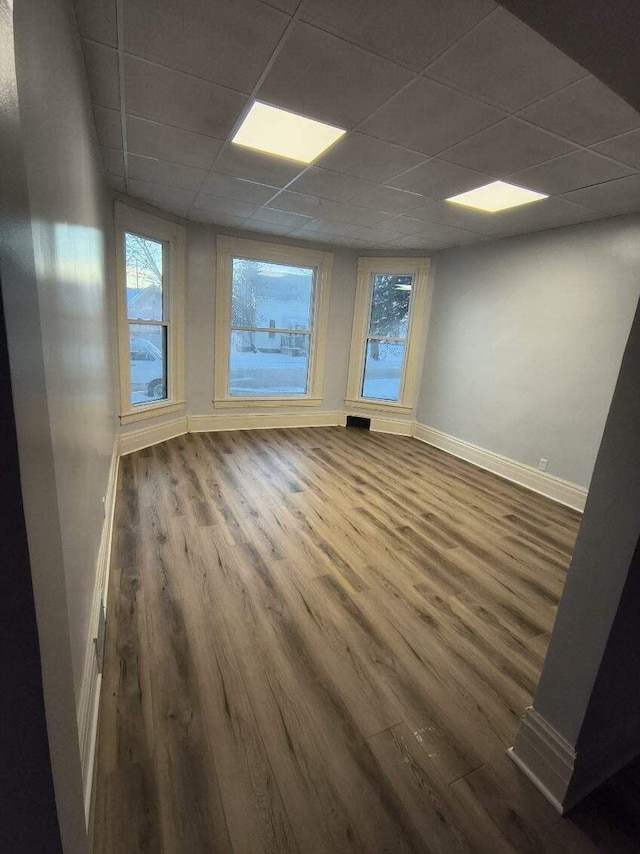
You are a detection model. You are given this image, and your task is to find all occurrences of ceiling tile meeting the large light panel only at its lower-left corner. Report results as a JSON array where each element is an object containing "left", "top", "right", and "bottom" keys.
[{"left": 127, "top": 116, "right": 222, "bottom": 169}]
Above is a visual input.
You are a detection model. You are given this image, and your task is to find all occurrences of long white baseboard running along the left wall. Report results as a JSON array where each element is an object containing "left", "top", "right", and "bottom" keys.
[{"left": 78, "top": 440, "right": 120, "bottom": 826}]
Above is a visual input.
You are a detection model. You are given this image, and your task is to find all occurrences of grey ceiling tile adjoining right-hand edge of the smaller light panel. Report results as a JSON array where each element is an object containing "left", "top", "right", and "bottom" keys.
[{"left": 508, "top": 150, "right": 632, "bottom": 196}]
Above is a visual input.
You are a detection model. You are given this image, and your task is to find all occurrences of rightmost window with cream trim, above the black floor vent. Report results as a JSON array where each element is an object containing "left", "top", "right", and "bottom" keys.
[{"left": 346, "top": 258, "right": 429, "bottom": 413}]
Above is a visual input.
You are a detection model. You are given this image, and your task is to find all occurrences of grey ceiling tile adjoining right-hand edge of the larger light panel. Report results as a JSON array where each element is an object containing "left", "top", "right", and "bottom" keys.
[{"left": 316, "top": 131, "right": 425, "bottom": 182}]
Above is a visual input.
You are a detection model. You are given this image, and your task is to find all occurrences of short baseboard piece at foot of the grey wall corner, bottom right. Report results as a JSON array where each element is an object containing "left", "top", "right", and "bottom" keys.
[{"left": 507, "top": 706, "right": 576, "bottom": 815}]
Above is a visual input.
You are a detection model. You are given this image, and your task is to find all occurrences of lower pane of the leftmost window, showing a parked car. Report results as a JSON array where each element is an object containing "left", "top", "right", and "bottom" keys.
[{"left": 129, "top": 323, "right": 167, "bottom": 404}]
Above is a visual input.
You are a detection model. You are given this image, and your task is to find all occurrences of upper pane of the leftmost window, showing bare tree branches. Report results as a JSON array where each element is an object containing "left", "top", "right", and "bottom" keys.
[{"left": 124, "top": 232, "right": 164, "bottom": 320}]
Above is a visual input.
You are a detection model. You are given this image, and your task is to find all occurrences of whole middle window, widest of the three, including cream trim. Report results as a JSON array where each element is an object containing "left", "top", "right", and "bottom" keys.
[{"left": 214, "top": 237, "right": 332, "bottom": 407}]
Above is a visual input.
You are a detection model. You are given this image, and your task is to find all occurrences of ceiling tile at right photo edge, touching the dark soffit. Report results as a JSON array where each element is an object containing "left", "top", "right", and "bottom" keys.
[{"left": 520, "top": 77, "right": 640, "bottom": 145}]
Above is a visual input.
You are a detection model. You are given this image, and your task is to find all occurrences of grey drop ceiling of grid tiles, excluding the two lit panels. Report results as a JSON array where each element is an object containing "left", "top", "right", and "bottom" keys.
[{"left": 76, "top": 0, "right": 640, "bottom": 250}]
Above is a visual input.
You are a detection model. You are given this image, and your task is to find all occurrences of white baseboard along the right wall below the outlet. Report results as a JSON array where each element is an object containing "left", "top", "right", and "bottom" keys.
[{"left": 413, "top": 421, "right": 588, "bottom": 512}]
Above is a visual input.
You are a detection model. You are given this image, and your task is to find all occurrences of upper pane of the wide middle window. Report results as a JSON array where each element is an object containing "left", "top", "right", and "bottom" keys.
[{"left": 231, "top": 258, "right": 314, "bottom": 329}]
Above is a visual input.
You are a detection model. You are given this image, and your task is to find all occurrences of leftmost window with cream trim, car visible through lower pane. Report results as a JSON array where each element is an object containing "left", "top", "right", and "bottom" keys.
[{"left": 116, "top": 204, "right": 184, "bottom": 424}]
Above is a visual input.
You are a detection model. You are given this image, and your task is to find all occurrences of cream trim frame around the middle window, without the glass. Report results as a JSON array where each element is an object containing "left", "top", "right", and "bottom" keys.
[{"left": 213, "top": 235, "right": 333, "bottom": 409}]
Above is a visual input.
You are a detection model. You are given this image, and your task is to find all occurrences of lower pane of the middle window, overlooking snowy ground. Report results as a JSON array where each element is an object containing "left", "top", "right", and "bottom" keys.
[{"left": 229, "top": 332, "right": 310, "bottom": 396}]
